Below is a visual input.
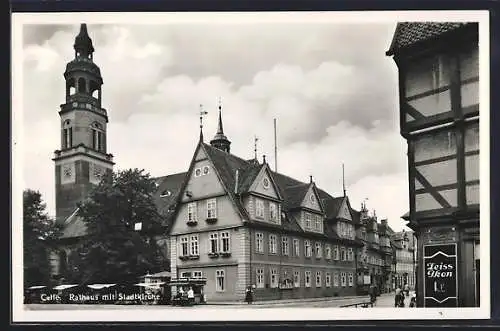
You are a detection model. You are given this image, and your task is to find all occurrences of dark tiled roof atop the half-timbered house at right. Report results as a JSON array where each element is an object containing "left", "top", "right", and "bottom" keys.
[{"left": 386, "top": 22, "right": 471, "bottom": 55}]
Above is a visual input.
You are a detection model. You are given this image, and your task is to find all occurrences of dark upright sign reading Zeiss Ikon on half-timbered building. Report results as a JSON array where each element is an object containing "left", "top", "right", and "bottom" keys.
[{"left": 424, "top": 244, "right": 458, "bottom": 307}]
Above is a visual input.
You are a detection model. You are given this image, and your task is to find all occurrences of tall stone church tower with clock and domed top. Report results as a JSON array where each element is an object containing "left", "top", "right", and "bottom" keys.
[{"left": 53, "top": 24, "right": 114, "bottom": 222}]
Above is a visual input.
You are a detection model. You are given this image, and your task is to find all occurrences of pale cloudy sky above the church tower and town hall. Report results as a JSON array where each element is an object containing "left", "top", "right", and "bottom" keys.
[{"left": 22, "top": 21, "right": 409, "bottom": 231}]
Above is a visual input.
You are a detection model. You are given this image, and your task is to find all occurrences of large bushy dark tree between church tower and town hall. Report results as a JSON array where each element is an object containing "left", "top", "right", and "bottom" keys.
[{"left": 69, "top": 169, "right": 161, "bottom": 283}]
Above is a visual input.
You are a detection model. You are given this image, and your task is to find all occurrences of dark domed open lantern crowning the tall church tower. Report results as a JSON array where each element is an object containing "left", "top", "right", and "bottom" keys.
[{"left": 64, "top": 24, "right": 103, "bottom": 108}]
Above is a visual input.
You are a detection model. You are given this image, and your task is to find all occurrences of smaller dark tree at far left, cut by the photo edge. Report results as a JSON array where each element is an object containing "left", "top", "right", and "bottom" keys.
[{"left": 23, "top": 189, "right": 60, "bottom": 287}]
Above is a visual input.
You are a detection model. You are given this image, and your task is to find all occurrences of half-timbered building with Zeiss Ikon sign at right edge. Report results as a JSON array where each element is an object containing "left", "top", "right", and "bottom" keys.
[{"left": 386, "top": 22, "right": 479, "bottom": 307}]
